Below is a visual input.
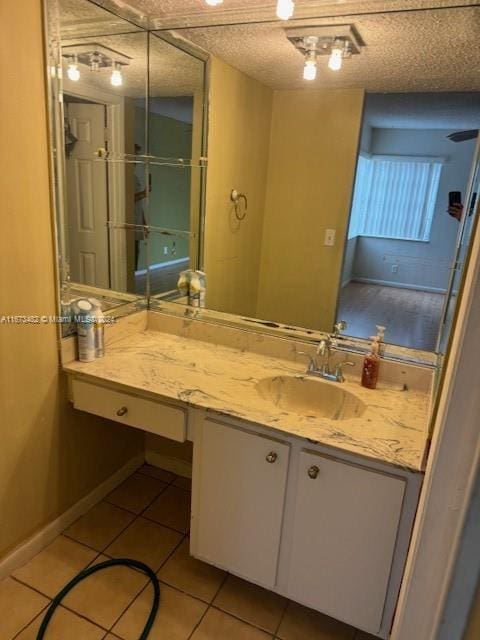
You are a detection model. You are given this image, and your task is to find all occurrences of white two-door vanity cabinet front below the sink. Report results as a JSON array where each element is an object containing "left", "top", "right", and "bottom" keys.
[{"left": 190, "top": 411, "right": 421, "bottom": 638}]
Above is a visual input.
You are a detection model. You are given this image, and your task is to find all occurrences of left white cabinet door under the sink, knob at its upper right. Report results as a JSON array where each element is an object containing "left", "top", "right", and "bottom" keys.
[{"left": 191, "top": 420, "right": 290, "bottom": 587}]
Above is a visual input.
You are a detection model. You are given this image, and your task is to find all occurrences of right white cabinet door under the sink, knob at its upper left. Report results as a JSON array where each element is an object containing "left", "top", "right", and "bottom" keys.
[{"left": 288, "top": 451, "right": 405, "bottom": 633}]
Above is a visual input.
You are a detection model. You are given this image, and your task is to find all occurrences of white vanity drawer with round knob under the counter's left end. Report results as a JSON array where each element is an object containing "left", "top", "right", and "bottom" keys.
[{"left": 72, "top": 379, "right": 187, "bottom": 442}]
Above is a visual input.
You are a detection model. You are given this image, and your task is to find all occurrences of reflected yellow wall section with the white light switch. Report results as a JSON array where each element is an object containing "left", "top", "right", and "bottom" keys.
[{"left": 256, "top": 89, "right": 364, "bottom": 331}]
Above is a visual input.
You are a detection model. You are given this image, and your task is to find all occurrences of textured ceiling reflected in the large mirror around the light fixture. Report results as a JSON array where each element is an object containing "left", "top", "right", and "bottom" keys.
[{"left": 177, "top": 7, "right": 480, "bottom": 92}]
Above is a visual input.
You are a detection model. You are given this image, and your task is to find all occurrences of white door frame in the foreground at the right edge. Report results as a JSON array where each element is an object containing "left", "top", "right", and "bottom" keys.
[{"left": 391, "top": 146, "right": 480, "bottom": 640}]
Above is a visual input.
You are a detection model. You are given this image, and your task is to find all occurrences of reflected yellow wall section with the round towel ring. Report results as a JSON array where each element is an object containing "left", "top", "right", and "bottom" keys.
[{"left": 205, "top": 58, "right": 273, "bottom": 316}]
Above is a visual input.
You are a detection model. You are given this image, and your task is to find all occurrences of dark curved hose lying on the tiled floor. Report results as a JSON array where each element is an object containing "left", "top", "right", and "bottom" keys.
[{"left": 37, "top": 558, "right": 160, "bottom": 640}]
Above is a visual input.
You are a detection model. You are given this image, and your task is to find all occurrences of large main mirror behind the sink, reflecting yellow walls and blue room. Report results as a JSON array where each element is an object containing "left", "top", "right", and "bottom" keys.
[{"left": 171, "top": 7, "right": 480, "bottom": 350}]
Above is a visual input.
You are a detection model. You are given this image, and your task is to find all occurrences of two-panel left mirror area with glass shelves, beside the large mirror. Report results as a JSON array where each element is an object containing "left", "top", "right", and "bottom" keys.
[{"left": 59, "top": 0, "right": 205, "bottom": 316}]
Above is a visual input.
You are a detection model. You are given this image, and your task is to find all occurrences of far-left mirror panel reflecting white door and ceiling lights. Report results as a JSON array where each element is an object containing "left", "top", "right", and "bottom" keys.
[{"left": 62, "top": 24, "right": 147, "bottom": 295}]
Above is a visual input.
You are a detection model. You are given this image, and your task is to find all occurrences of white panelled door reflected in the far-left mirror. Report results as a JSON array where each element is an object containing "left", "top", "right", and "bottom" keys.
[{"left": 65, "top": 103, "right": 110, "bottom": 289}]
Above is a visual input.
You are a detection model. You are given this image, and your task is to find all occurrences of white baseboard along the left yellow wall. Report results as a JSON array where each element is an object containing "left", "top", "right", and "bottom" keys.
[{"left": 0, "top": 453, "right": 145, "bottom": 579}]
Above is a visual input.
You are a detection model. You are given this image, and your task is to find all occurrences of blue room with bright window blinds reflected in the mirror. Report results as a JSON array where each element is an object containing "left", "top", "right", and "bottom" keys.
[{"left": 337, "top": 93, "right": 480, "bottom": 351}]
